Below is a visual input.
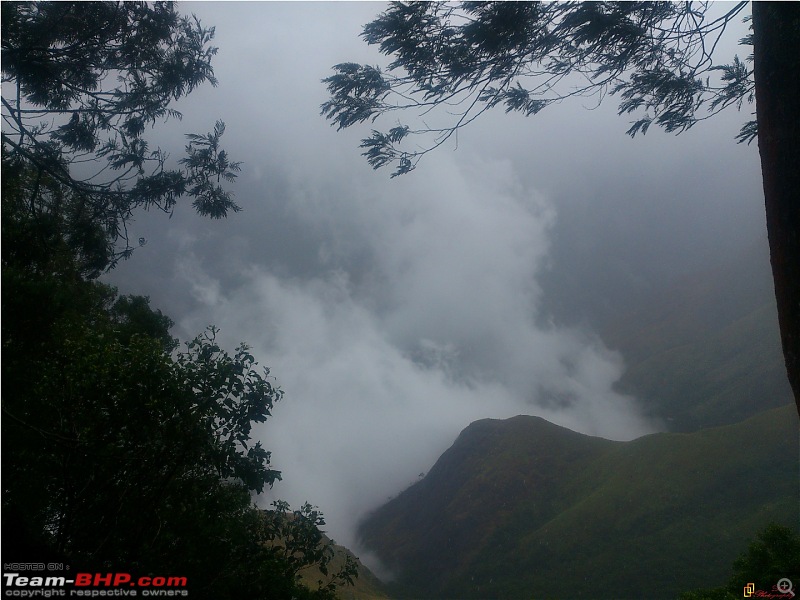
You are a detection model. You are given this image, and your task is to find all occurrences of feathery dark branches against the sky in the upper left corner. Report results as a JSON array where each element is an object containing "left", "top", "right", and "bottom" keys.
[{"left": 2, "top": 2, "right": 240, "bottom": 270}]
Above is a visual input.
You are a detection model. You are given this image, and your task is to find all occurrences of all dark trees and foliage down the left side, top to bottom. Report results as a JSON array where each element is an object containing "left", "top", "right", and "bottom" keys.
[{"left": 2, "top": 2, "right": 356, "bottom": 599}]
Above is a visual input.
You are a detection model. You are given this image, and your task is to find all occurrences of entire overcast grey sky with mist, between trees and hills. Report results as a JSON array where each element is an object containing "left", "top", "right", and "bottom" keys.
[{"left": 107, "top": 2, "right": 766, "bottom": 567}]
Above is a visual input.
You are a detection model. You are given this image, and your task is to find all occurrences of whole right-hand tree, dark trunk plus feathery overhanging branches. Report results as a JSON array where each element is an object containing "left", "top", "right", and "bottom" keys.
[{"left": 321, "top": 2, "right": 800, "bottom": 420}]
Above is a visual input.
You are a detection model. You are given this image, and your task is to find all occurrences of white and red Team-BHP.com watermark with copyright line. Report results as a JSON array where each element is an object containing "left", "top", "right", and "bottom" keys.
[{"left": 3, "top": 562, "right": 189, "bottom": 598}]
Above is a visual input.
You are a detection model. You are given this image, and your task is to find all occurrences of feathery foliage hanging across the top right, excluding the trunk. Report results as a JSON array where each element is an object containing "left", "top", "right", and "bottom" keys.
[{"left": 322, "top": 2, "right": 756, "bottom": 177}]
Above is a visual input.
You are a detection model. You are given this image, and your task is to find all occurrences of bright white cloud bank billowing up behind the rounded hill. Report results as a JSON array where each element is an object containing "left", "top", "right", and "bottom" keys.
[{"left": 167, "top": 156, "right": 657, "bottom": 547}]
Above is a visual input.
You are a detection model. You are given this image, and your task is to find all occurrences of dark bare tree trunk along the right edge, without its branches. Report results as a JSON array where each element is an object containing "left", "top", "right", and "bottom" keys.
[{"left": 753, "top": 2, "right": 800, "bottom": 420}]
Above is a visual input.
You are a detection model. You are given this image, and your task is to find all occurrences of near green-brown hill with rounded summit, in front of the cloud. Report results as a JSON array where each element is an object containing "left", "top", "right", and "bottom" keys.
[{"left": 360, "top": 405, "right": 800, "bottom": 598}]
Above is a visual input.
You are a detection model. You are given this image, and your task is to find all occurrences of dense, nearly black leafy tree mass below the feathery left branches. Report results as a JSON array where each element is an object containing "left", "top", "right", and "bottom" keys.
[{"left": 2, "top": 276, "right": 354, "bottom": 598}]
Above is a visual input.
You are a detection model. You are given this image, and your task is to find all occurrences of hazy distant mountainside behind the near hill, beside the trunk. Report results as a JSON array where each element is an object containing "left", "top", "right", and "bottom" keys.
[{"left": 599, "top": 239, "right": 793, "bottom": 431}]
